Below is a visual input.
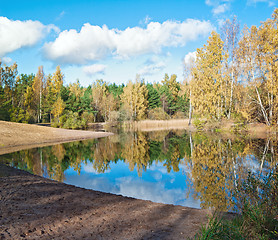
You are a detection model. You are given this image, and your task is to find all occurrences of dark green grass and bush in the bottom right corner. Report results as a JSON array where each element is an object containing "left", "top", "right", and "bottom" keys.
[{"left": 195, "top": 169, "right": 278, "bottom": 240}]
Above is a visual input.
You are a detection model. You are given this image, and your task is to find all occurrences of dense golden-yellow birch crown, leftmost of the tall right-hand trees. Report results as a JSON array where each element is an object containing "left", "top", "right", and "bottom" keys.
[{"left": 190, "top": 32, "right": 228, "bottom": 120}]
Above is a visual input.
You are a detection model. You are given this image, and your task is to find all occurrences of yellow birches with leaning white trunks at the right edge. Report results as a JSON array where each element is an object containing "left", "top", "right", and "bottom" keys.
[{"left": 239, "top": 9, "right": 278, "bottom": 125}]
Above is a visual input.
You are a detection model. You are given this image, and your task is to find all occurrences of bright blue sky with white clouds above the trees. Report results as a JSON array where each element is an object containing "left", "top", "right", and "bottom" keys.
[{"left": 0, "top": 0, "right": 278, "bottom": 86}]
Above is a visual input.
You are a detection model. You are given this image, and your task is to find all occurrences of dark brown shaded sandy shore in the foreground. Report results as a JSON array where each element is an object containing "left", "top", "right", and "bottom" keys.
[{"left": 0, "top": 165, "right": 211, "bottom": 240}]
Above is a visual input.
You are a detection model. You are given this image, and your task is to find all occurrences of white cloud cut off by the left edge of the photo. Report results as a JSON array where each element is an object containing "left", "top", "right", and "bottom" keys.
[{"left": 0, "top": 17, "right": 59, "bottom": 56}]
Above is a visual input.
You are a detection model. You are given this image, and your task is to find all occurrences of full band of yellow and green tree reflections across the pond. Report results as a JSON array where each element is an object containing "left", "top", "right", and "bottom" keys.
[{"left": 0, "top": 130, "right": 278, "bottom": 211}]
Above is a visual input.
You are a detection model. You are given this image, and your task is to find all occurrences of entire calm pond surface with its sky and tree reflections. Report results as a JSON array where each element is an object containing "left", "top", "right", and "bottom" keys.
[{"left": 0, "top": 131, "right": 278, "bottom": 210}]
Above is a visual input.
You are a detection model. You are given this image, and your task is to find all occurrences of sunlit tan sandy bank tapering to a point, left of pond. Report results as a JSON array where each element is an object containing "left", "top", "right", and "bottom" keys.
[{"left": 0, "top": 121, "right": 113, "bottom": 154}]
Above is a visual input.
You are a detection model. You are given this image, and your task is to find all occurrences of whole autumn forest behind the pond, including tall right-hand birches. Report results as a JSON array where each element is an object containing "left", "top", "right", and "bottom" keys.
[{"left": 0, "top": 9, "right": 278, "bottom": 129}]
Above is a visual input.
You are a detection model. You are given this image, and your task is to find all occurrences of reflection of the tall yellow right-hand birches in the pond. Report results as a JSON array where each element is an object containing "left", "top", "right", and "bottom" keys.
[{"left": 187, "top": 135, "right": 277, "bottom": 211}]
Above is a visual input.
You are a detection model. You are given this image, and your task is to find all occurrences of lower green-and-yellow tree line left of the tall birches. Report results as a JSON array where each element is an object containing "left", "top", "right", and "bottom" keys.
[{"left": 0, "top": 63, "right": 188, "bottom": 128}]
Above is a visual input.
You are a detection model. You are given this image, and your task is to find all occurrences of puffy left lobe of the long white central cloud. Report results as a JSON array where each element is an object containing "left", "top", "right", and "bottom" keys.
[{"left": 44, "top": 23, "right": 115, "bottom": 64}]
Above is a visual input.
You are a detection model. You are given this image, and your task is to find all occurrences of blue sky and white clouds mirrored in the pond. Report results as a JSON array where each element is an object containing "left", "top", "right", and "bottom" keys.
[{"left": 65, "top": 163, "right": 200, "bottom": 208}]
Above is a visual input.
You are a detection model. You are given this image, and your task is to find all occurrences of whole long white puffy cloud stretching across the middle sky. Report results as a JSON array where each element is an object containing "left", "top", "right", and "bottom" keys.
[{"left": 44, "top": 19, "right": 213, "bottom": 64}]
